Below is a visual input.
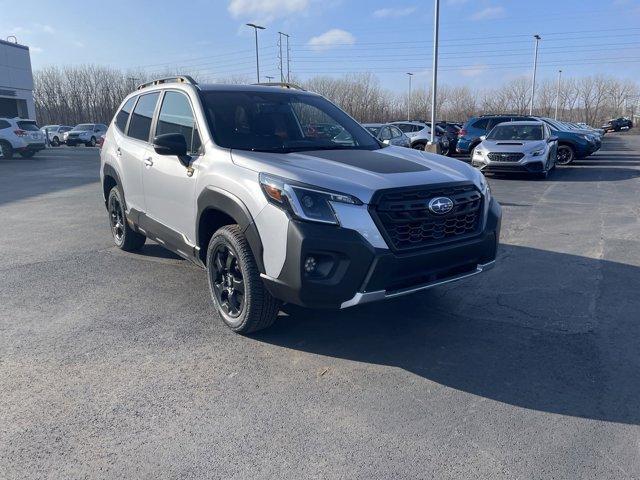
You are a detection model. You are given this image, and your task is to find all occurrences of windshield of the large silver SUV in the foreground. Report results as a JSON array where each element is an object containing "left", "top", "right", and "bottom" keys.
[{"left": 202, "top": 91, "right": 381, "bottom": 153}]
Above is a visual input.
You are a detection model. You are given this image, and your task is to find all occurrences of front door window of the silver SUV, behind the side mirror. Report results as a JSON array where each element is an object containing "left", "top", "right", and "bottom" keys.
[{"left": 156, "top": 91, "right": 201, "bottom": 153}]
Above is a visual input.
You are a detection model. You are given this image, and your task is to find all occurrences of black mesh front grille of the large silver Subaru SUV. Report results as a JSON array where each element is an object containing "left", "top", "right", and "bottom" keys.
[{"left": 372, "top": 184, "right": 482, "bottom": 250}]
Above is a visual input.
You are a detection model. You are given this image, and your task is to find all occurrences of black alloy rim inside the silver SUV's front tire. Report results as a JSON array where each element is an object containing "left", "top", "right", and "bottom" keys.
[{"left": 212, "top": 244, "right": 245, "bottom": 318}]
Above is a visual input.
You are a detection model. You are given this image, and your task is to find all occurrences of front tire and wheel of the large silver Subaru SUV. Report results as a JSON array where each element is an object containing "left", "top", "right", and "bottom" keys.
[{"left": 207, "top": 225, "right": 281, "bottom": 334}]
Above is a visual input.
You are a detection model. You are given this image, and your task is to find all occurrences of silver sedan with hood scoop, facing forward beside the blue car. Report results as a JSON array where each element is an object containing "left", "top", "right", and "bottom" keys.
[{"left": 471, "top": 121, "right": 558, "bottom": 178}]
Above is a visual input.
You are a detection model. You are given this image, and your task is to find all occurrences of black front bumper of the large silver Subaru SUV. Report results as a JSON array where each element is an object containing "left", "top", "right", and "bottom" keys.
[{"left": 262, "top": 200, "right": 502, "bottom": 309}]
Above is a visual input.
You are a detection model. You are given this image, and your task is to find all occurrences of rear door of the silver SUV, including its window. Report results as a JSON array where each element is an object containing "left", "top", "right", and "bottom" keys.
[{"left": 120, "top": 92, "right": 160, "bottom": 213}]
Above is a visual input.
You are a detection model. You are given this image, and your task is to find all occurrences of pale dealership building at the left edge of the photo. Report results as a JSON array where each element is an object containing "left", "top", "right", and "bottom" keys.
[{"left": 0, "top": 40, "right": 36, "bottom": 119}]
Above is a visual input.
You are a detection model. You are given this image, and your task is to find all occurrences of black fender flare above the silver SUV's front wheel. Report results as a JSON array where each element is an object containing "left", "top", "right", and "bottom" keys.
[{"left": 196, "top": 186, "right": 265, "bottom": 273}]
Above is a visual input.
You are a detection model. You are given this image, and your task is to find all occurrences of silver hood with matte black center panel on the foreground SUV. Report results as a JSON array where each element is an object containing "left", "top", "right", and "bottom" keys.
[{"left": 231, "top": 146, "right": 483, "bottom": 203}]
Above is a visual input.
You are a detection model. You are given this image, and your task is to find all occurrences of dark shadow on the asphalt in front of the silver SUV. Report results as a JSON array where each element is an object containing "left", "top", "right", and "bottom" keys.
[{"left": 255, "top": 245, "right": 640, "bottom": 424}]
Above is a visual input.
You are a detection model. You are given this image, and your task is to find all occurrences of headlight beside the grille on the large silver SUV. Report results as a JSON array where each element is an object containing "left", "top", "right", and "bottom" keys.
[{"left": 260, "top": 173, "right": 362, "bottom": 225}]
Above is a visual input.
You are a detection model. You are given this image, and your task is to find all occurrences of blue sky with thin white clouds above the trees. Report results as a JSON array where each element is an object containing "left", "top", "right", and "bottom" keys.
[{"left": 0, "top": 0, "right": 640, "bottom": 91}]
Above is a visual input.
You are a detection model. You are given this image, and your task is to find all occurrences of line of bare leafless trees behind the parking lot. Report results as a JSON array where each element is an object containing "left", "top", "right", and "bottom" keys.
[{"left": 34, "top": 65, "right": 640, "bottom": 125}]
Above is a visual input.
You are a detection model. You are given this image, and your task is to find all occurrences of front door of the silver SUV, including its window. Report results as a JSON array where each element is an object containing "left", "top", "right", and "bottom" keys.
[{"left": 143, "top": 90, "right": 201, "bottom": 246}]
